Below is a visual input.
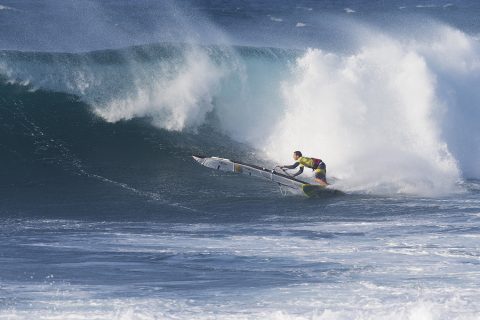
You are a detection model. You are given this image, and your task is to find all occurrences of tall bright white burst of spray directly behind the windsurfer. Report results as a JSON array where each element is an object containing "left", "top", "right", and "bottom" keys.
[{"left": 267, "top": 43, "right": 459, "bottom": 193}]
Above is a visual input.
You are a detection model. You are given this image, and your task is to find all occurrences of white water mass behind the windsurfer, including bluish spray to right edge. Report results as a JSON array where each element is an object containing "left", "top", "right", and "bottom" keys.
[{"left": 258, "top": 28, "right": 480, "bottom": 195}]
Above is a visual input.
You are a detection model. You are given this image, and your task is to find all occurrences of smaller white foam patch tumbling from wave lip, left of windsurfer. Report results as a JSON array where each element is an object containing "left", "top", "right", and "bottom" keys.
[{"left": 95, "top": 49, "right": 227, "bottom": 131}]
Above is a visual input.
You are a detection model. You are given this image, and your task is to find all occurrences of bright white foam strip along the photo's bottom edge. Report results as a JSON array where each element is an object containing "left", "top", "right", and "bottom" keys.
[{"left": 0, "top": 270, "right": 480, "bottom": 320}]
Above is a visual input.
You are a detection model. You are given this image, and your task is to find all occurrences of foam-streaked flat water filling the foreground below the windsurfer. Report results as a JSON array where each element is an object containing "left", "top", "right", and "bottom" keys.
[{"left": 0, "top": 216, "right": 480, "bottom": 320}]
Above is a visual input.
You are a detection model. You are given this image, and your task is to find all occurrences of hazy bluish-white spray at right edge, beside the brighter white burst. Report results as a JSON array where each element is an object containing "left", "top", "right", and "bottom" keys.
[{"left": 412, "top": 25, "right": 480, "bottom": 179}]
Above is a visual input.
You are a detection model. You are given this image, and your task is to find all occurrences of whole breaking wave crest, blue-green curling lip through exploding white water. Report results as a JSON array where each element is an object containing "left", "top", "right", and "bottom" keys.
[{"left": 0, "top": 25, "right": 480, "bottom": 195}]
